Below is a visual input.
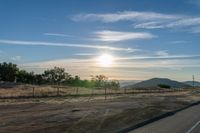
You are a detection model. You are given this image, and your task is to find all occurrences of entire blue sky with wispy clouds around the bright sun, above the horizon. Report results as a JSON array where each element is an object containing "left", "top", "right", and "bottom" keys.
[{"left": 0, "top": 0, "right": 200, "bottom": 81}]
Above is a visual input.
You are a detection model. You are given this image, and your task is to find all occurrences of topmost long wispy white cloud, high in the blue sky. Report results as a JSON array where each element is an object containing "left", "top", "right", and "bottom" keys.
[{"left": 72, "top": 11, "right": 180, "bottom": 23}]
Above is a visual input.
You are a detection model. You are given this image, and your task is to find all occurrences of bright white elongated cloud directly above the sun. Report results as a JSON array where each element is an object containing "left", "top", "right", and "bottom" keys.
[{"left": 95, "top": 30, "right": 156, "bottom": 42}]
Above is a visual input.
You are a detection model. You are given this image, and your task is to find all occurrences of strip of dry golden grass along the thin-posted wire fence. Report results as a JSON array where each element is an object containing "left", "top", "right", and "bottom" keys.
[{"left": 0, "top": 85, "right": 197, "bottom": 99}]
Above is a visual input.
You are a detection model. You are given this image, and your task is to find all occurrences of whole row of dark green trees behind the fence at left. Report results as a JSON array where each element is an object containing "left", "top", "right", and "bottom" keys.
[{"left": 0, "top": 62, "right": 119, "bottom": 89}]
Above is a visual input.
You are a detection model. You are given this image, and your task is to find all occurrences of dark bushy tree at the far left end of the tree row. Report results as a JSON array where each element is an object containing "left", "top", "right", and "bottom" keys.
[{"left": 0, "top": 62, "right": 19, "bottom": 82}]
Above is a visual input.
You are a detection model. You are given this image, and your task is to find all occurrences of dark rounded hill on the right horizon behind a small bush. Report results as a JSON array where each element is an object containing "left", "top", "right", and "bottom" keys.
[{"left": 126, "top": 78, "right": 190, "bottom": 88}]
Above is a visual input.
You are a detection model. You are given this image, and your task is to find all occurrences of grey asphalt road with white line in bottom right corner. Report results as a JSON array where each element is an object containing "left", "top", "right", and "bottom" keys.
[{"left": 130, "top": 105, "right": 200, "bottom": 133}]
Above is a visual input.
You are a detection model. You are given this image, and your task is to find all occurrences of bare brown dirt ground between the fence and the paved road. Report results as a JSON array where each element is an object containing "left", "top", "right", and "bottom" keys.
[{"left": 0, "top": 91, "right": 200, "bottom": 133}]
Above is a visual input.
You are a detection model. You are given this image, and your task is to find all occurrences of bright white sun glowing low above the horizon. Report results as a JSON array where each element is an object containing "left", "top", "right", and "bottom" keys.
[{"left": 98, "top": 54, "right": 113, "bottom": 67}]
